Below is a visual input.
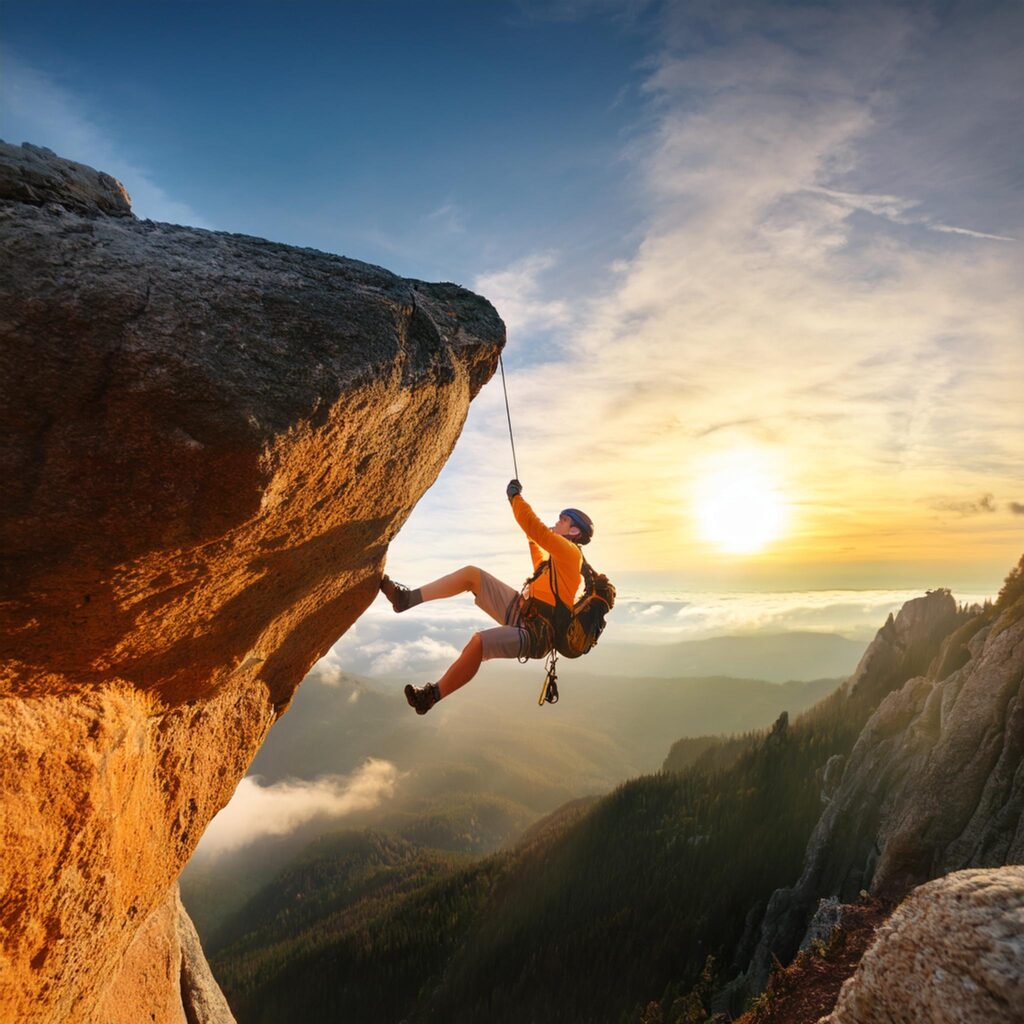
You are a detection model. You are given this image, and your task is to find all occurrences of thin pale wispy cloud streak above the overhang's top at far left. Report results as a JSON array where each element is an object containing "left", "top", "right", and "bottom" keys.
[{"left": 0, "top": 48, "right": 213, "bottom": 227}]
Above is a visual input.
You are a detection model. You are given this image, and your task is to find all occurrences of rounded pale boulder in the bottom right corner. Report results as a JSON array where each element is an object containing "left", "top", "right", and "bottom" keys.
[{"left": 824, "top": 867, "right": 1024, "bottom": 1024}]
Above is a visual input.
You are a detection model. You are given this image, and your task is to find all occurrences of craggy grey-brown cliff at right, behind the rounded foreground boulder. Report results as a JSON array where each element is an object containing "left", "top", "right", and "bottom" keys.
[{"left": 742, "top": 591, "right": 1024, "bottom": 993}]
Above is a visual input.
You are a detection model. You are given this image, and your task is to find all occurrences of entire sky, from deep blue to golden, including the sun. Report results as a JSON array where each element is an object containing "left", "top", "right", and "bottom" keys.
[{"left": 0, "top": 0, "right": 1024, "bottom": 643}]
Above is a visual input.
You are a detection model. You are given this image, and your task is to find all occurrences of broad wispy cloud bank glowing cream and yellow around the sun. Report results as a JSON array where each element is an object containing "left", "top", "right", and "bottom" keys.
[{"left": 399, "top": 4, "right": 1024, "bottom": 593}]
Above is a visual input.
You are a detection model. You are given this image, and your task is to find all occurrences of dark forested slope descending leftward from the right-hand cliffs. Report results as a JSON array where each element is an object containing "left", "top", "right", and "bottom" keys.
[{"left": 205, "top": 598, "right": 953, "bottom": 1024}]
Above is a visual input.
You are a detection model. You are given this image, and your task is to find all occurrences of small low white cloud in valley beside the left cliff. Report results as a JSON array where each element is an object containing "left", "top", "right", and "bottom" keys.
[{"left": 198, "top": 758, "right": 400, "bottom": 856}]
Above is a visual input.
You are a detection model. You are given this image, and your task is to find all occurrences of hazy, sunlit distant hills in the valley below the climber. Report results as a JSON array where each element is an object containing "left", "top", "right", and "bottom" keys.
[{"left": 181, "top": 666, "right": 839, "bottom": 945}]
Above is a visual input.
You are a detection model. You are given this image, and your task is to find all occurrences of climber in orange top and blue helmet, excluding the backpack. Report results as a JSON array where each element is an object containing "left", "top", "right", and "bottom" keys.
[{"left": 380, "top": 480, "right": 594, "bottom": 715}]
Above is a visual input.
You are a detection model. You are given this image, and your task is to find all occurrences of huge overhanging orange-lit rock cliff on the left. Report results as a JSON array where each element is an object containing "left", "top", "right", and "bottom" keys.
[{"left": 0, "top": 143, "right": 504, "bottom": 1022}]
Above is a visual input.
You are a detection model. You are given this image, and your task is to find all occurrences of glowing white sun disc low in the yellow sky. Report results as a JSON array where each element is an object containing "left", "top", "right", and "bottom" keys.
[{"left": 693, "top": 452, "right": 786, "bottom": 555}]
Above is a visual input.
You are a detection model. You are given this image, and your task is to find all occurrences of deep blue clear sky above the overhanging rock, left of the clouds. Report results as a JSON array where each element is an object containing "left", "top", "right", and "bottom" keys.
[{"left": 2, "top": 0, "right": 649, "bottom": 281}]
